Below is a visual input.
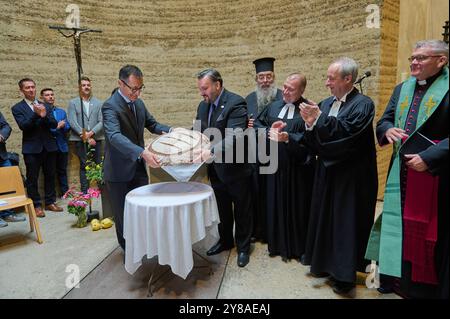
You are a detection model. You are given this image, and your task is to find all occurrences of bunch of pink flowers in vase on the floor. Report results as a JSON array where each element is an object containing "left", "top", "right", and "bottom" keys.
[{"left": 63, "top": 188, "right": 100, "bottom": 228}]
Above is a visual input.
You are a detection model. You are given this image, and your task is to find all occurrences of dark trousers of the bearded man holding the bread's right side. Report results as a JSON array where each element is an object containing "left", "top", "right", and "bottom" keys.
[{"left": 209, "top": 167, "right": 253, "bottom": 253}]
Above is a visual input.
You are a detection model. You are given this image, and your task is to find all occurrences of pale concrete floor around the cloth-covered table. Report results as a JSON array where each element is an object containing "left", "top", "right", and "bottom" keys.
[{"left": 0, "top": 198, "right": 398, "bottom": 299}]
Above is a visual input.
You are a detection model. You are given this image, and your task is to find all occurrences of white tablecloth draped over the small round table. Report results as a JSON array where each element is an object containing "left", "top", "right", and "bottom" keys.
[{"left": 123, "top": 182, "right": 220, "bottom": 279}]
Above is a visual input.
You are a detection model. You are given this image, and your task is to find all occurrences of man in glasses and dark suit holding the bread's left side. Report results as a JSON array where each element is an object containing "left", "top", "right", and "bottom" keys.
[{"left": 102, "top": 65, "right": 170, "bottom": 250}]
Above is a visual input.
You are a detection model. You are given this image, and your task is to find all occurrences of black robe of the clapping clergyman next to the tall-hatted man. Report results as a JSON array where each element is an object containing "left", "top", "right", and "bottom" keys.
[{"left": 255, "top": 99, "right": 314, "bottom": 259}]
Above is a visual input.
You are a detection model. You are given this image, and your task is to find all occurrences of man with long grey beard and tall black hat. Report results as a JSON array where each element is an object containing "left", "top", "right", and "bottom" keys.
[{"left": 245, "top": 58, "right": 283, "bottom": 242}]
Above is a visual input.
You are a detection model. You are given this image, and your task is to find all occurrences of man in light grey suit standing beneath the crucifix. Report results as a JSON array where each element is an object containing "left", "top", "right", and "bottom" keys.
[{"left": 67, "top": 76, "right": 105, "bottom": 193}]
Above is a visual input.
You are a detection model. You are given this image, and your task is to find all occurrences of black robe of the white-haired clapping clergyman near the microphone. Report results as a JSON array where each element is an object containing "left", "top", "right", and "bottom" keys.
[{"left": 303, "top": 88, "right": 378, "bottom": 282}]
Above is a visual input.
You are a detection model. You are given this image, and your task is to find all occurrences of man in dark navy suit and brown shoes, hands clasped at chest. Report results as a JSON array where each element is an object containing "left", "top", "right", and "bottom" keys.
[{"left": 12, "top": 78, "right": 63, "bottom": 217}]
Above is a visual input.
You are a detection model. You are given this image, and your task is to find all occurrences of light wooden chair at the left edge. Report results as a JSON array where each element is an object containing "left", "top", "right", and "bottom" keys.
[{"left": 0, "top": 166, "right": 42, "bottom": 244}]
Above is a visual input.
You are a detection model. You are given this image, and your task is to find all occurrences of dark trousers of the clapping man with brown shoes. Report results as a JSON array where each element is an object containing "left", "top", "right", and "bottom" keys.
[{"left": 23, "top": 150, "right": 56, "bottom": 207}]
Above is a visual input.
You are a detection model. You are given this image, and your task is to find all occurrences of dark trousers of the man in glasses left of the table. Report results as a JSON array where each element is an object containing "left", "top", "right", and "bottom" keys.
[{"left": 106, "top": 162, "right": 148, "bottom": 250}]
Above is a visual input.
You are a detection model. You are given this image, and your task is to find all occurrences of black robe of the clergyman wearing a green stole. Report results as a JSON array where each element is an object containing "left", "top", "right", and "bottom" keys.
[{"left": 376, "top": 71, "right": 450, "bottom": 299}]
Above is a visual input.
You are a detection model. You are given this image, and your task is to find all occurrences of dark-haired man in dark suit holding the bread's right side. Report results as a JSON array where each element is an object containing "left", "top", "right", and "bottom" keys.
[{"left": 197, "top": 69, "right": 252, "bottom": 267}]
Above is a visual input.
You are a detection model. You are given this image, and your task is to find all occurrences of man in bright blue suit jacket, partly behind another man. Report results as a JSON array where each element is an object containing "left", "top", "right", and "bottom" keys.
[{"left": 41, "top": 88, "right": 70, "bottom": 197}]
